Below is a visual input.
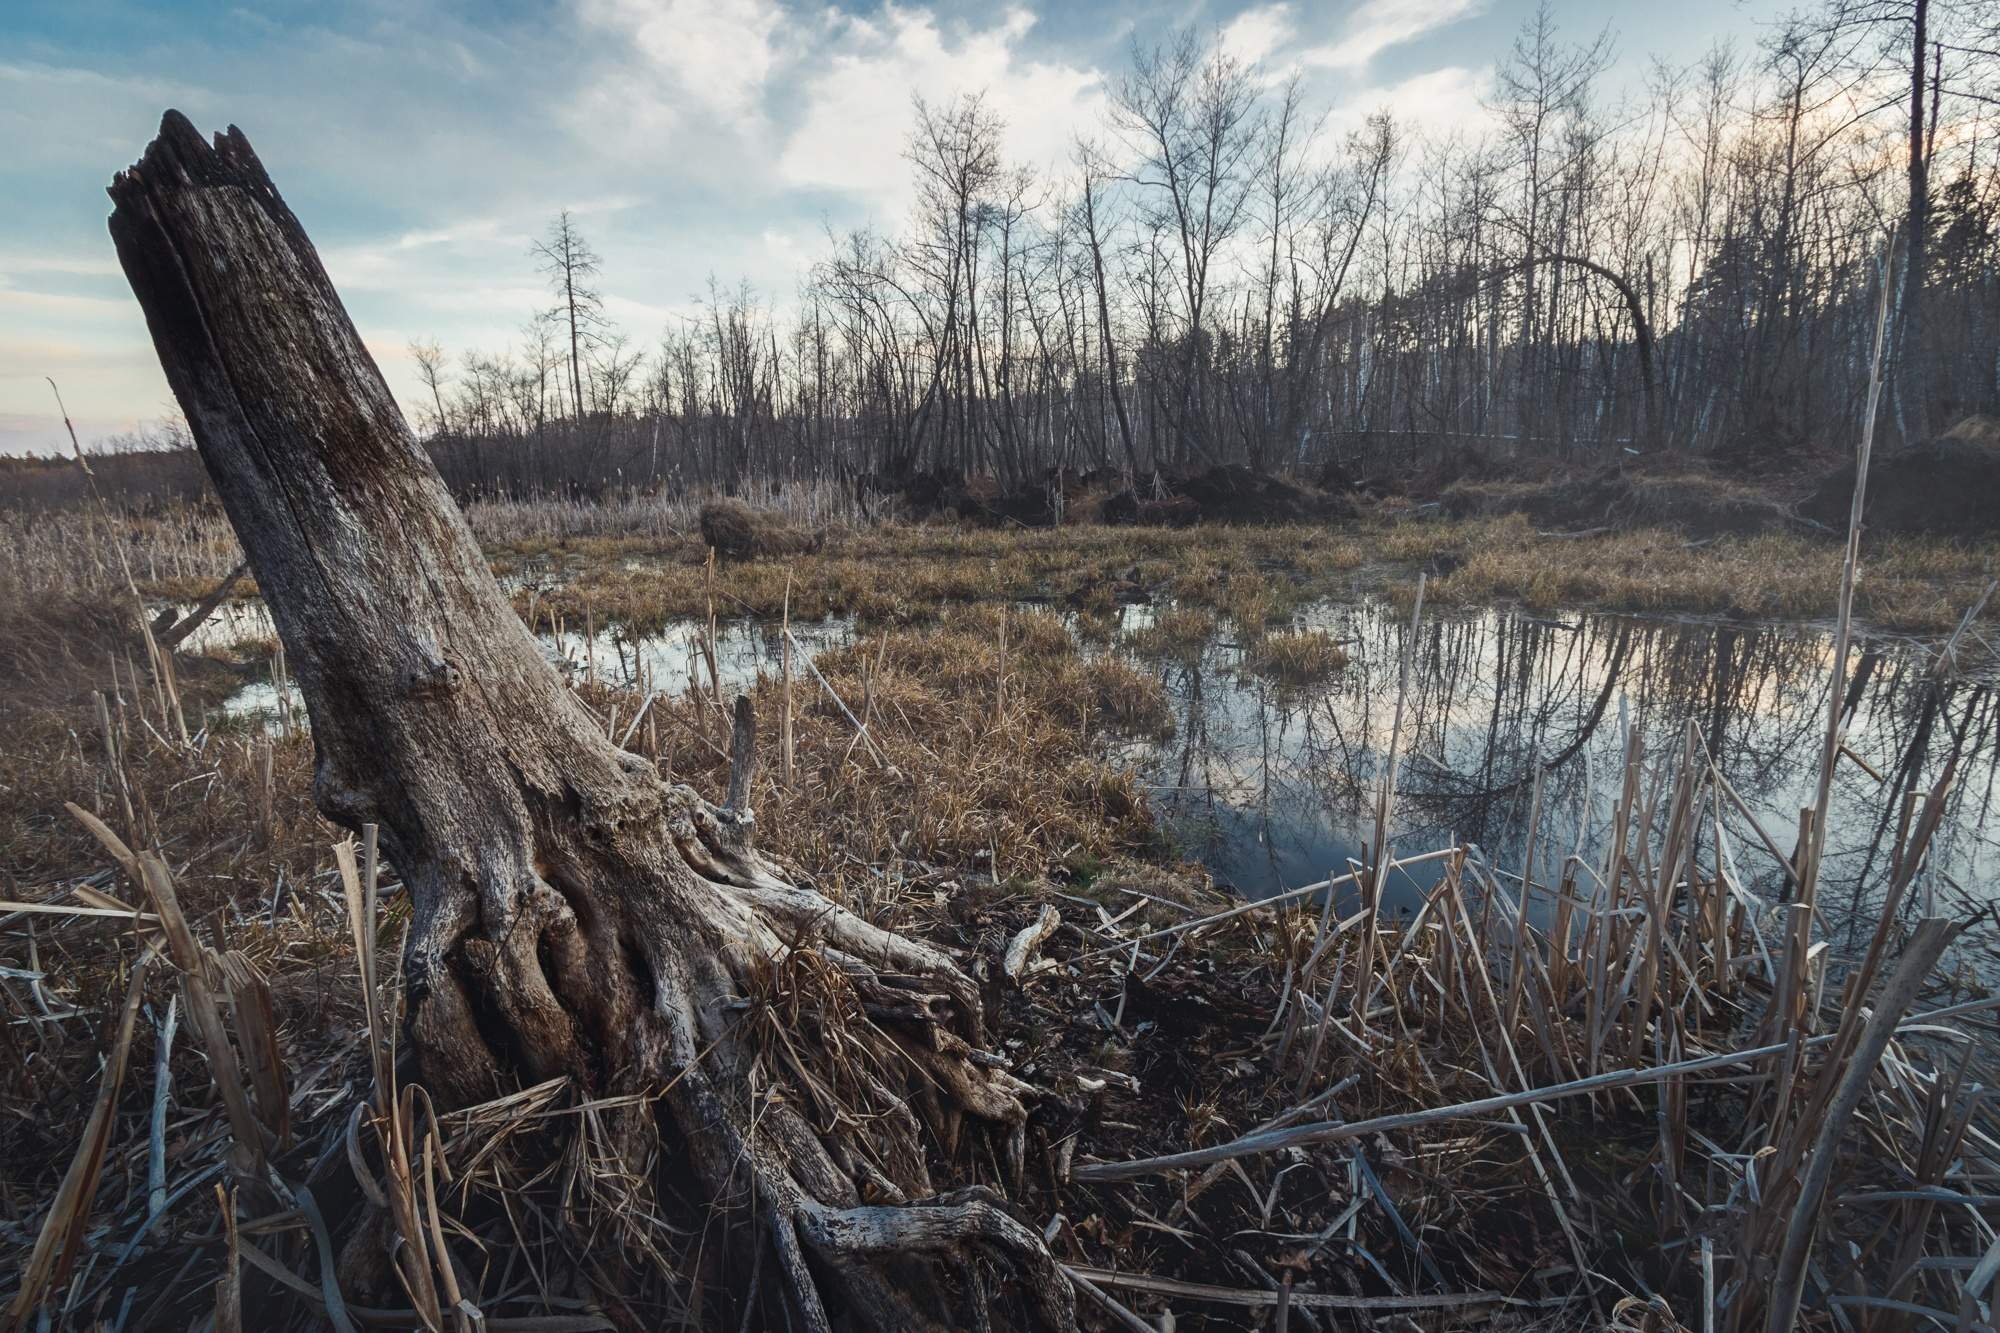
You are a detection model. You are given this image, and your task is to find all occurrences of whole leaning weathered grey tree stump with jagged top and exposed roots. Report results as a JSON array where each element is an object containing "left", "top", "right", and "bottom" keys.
[{"left": 110, "top": 112, "right": 1074, "bottom": 1329}]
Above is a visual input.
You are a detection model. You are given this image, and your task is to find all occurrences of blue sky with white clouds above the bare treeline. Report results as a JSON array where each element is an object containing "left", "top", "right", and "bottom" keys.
[{"left": 0, "top": 0, "right": 1780, "bottom": 454}]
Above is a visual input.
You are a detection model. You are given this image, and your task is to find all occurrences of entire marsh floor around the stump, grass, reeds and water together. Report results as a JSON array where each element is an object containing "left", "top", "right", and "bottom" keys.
[{"left": 0, "top": 506, "right": 2000, "bottom": 1329}]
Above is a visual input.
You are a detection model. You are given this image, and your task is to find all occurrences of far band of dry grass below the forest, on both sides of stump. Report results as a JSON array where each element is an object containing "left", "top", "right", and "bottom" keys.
[{"left": 0, "top": 488, "right": 2000, "bottom": 636}]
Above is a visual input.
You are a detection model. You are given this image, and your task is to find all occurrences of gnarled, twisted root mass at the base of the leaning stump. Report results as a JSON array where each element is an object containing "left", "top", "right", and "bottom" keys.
[{"left": 368, "top": 701, "right": 1074, "bottom": 1329}]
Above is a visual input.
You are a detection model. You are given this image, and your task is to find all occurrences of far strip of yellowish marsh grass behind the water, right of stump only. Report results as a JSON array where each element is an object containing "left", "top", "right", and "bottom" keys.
[{"left": 488, "top": 514, "right": 2000, "bottom": 636}]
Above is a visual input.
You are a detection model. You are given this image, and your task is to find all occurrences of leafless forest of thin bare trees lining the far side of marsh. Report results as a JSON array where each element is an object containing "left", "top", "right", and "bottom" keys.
[{"left": 386, "top": 0, "right": 2000, "bottom": 498}]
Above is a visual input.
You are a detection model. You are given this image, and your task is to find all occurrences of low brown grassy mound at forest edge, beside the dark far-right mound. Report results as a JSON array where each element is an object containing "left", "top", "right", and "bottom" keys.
[{"left": 1440, "top": 466, "right": 1790, "bottom": 536}]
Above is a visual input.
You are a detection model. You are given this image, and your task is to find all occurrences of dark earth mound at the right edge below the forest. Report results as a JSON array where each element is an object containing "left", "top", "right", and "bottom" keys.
[{"left": 1800, "top": 416, "right": 2000, "bottom": 536}]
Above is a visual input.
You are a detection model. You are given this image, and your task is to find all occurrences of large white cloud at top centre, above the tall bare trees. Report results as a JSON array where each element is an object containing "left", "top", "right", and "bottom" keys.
[{"left": 778, "top": 4, "right": 1104, "bottom": 210}]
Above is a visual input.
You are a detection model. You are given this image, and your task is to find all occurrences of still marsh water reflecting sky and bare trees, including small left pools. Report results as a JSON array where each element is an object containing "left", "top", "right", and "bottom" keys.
[{"left": 196, "top": 600, "right": 2000, "bottom": 956}]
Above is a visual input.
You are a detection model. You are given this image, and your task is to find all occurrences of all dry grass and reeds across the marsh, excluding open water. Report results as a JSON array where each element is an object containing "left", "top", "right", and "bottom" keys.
[{"left": 0, "top": 480, "right": 2000, "bottom": 1331}]
